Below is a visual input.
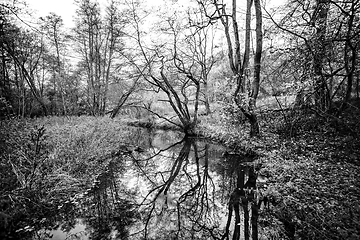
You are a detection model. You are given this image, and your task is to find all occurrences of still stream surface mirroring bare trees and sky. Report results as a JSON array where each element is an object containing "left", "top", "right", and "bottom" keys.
[{"left": 34, "top": 129, "right": 276, "bottom": 240}]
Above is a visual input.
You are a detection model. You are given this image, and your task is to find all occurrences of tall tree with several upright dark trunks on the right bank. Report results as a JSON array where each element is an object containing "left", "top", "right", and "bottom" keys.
[{"left": 197, "top": 0, "right": 262, "bottom": 136}]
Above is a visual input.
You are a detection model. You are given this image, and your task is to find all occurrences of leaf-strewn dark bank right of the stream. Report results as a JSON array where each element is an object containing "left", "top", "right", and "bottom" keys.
[{"left": 199, "top": 109, "right": 360, "bottom": 240}]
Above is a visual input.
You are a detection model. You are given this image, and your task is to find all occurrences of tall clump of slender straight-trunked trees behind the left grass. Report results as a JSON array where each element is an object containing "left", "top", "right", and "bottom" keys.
[{"left": 75, "top": 0, "right": 125, "bottom": 115}]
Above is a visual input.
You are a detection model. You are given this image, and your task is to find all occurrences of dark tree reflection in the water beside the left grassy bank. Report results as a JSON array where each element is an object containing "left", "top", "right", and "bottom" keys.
[{"left": 80, "top": 155, "right": 137, "bottom": 239}]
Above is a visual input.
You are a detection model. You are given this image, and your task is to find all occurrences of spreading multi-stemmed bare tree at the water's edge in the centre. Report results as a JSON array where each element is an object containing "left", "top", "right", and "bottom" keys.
[{"left": 124, "top": 2, "right": 217, "bottom": 135}]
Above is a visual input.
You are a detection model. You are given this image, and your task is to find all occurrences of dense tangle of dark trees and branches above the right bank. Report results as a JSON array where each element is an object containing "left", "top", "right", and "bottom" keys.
[{"left": 269, "top": 0, "right": 360, "bottom": 113}]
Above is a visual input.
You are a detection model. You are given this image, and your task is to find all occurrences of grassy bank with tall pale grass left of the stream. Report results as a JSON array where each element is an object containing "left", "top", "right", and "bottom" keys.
[{"left": 0, "top": 117, "right": 133, "bottom": 239}]
